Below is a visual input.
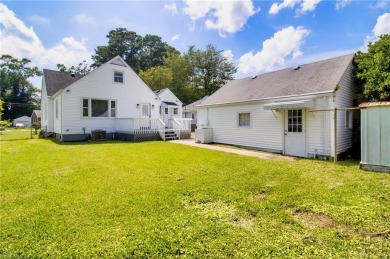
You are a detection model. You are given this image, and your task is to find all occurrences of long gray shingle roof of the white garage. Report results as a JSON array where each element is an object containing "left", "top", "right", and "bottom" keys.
[{"left": 200, "top": 54, "right": 355, "bottom": 106}]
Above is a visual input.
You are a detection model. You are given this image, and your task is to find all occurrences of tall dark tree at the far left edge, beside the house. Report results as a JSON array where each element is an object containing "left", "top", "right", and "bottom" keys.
[{"left": 0, "top": 55, "right": 42, "bottom": 120}]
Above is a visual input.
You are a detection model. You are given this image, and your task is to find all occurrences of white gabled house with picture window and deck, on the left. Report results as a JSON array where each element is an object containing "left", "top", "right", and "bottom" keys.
[{"left": 41, "top": 56, "right": 190, "bottom": 141}]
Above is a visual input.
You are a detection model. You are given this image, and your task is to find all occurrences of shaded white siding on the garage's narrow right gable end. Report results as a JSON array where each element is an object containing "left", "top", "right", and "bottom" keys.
[{"left": 334, "top": 61, "right": 355, "bottom": 154}]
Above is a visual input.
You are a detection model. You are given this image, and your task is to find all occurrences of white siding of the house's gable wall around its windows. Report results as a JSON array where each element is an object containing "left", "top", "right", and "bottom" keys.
[{"left": 62, "top": 63, "right": 160, "bottom": 134}]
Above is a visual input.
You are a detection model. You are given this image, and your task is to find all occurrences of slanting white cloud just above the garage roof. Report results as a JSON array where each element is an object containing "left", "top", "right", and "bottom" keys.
[{"left": 238, "top": 26, "right": 310, "bottom": 73}]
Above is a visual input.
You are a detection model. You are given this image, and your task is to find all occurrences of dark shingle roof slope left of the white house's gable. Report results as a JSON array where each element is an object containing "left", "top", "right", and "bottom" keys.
[{"left": 43, "top": 69, "right": 83, "bottom": 96}]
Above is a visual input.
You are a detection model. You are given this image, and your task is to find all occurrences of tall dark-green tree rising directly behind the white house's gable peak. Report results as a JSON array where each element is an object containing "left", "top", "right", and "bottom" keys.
[{"left": 92, "top": 28, "right": 178, "bottom": 73}]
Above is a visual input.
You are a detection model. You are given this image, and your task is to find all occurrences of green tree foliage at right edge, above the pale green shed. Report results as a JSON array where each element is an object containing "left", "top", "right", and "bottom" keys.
[{"left": 355, "top": 34, "right": 390, "bottom": 101}]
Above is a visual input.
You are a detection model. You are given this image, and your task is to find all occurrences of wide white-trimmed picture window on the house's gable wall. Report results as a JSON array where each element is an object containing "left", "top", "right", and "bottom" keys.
[{"left": 81, "top": 98, "right": 116, "bottom": 118}]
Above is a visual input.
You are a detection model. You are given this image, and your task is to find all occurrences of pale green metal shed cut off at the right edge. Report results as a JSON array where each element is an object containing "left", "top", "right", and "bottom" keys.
[{"left": 359, "top": 102, "right": 390, "bottom": 173}]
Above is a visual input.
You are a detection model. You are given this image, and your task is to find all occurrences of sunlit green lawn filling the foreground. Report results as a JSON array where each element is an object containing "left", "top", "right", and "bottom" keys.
[{"left": 0, "top": 139, "right": 390, "bottom": 258}]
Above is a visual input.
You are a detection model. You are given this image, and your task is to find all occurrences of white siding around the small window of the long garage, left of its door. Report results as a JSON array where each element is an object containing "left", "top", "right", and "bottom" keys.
[{"left": 198, "top": 104, "right": 284, "bottom": 152}]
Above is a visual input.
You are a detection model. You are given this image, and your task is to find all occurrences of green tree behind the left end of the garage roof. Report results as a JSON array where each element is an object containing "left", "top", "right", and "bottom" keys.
[{"left": 184, "top": 45, "right": 237, "bottom": 95}]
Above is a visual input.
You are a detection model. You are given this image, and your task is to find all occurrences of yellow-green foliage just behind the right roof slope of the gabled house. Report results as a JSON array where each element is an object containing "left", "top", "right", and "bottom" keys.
[{"left": 139, "top": 66, "right": 172, "bottom": 91}]
